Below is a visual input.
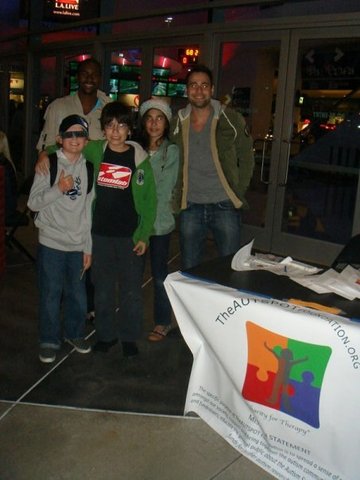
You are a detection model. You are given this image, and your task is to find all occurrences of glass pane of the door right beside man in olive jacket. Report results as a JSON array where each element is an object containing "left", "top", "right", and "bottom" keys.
[{"left": 218, "top": 41, "right": 280, "bottom": 228}]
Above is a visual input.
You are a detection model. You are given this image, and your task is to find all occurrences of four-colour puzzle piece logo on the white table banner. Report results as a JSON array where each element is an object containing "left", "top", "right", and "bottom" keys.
[{"left": 242, "top": 322, "right": 331, "bottom": 428}]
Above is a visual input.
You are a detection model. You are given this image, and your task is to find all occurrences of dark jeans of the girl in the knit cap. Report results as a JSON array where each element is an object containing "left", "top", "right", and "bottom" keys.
[{"left": 150, "top": 233, "right": 171, "bottom": 325}]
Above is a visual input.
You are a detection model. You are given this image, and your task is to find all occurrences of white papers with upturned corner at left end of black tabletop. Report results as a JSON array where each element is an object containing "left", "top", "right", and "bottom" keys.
[{"left": 231, "top": 240, "right": 321, "bottom": 277}]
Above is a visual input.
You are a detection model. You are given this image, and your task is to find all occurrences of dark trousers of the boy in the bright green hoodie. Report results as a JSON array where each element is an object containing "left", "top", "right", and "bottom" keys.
[{"left": 91, "top": 235, "right": 144, "bottom": 342}]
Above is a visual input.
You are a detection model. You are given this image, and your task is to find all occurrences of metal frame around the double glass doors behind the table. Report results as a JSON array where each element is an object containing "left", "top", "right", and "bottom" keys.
[{"left": 214, "top": 26, "right": 360, "bottom": 265}]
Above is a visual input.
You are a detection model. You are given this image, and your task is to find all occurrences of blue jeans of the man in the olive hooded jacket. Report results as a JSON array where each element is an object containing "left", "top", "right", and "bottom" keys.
[{"left": 180, "top": 200, "right": 241, "bottom": 270}]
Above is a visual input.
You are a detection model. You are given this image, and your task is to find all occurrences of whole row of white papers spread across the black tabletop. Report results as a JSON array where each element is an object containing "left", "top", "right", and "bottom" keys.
[{"left": 231, "top": 240, "right": 360, "bottom": 300}]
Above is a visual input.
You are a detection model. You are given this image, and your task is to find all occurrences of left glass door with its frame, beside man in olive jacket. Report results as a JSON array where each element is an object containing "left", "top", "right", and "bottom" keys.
[{"left": 216, "top": 32, "right": 290, "bottom": 251}]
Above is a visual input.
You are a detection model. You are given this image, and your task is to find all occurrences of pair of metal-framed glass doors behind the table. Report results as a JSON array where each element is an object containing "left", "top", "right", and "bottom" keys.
[{"left": 218, "top": 29, "right": 360, "bottom": 265}]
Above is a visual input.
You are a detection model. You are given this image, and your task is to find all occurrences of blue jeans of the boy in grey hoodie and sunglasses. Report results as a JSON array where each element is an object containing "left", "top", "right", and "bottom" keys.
[{"left": 37, "top": 244, "right": 86, "bottom": 349}]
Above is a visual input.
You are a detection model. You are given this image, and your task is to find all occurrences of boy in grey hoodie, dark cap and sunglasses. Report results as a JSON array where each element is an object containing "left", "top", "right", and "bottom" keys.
[{"left": 28, "top": 115, "right": 94, "bottom": 363}]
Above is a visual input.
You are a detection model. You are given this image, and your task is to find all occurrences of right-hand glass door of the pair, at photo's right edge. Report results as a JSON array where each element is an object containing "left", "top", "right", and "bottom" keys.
[{"left": 272, "top": 31, "right": 360, "bottom": 265}]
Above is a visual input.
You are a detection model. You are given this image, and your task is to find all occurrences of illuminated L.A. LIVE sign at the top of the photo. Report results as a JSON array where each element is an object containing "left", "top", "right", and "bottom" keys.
[{"left": 44, "top": 0, "right": 99, "bottom": 22}]
